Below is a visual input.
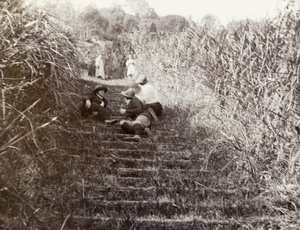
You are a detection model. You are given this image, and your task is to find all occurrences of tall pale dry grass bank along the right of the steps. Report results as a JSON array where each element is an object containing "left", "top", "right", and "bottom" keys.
[{"left": 128, "top": 2, "right": 300, "bottom": 227}]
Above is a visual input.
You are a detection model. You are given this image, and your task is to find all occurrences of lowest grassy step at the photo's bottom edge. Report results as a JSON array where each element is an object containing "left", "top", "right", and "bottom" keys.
[{"left": 72, "top": 215, "right": 280, "bottom": 230}]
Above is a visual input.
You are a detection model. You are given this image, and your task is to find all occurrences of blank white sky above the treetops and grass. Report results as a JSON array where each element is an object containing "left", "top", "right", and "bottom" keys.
[{"left": 27, "top": 0, "right": 290, "bottom": 25}]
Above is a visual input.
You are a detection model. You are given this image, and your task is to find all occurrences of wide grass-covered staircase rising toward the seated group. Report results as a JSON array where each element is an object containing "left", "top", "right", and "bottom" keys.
[{"left": 57, "top": 81, "right": 270, "bottom": 230}]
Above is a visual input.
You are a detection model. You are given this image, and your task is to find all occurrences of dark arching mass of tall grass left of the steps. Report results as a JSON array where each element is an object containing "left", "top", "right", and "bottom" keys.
[{"left": 0, "top": 0, "right": 78, "bottom": 226}]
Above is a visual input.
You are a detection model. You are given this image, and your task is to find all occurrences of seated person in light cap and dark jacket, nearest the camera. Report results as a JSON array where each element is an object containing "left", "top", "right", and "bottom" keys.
[{"left": 119, "top": 88, "right": 152, "bottom": 141}]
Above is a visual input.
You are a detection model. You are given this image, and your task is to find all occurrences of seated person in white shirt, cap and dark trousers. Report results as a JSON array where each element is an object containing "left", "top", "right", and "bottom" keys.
[{"left": 135, "top": 74, "right": 163, "bottom": 123}]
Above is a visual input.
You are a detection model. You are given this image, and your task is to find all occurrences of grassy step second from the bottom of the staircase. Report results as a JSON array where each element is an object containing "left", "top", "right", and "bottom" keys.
[{"left": 73, "top": 197, "right": 263, "bottom": 218}]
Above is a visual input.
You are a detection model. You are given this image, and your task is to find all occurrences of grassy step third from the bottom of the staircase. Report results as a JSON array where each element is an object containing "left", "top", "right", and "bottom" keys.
[{"left": 77, "top": 184, "right": 257, "bottom": 203}]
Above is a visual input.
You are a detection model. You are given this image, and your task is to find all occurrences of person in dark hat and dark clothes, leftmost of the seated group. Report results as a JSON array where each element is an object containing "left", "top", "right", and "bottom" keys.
[{"left": 80, "top": 85, "right": 110, "bottom": 122}]
